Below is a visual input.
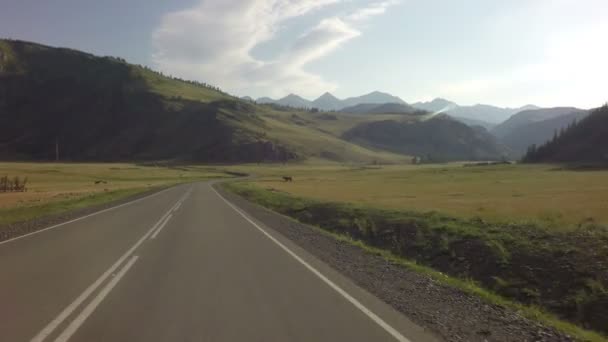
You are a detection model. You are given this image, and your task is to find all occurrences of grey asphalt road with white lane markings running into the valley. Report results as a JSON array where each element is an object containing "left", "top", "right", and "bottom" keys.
[{"left": 0, "top": 183, "right": 435, "bottom": 342}]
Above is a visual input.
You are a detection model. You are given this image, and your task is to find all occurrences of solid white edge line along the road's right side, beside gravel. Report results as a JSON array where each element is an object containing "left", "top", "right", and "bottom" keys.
[{"left": 210, "top": 186, "right": 411, "bottom": 342}]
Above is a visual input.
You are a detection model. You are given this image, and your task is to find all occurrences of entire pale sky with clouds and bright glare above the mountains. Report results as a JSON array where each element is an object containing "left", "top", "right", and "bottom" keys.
[{"left": 0, "top": 0, "right": 608, "bottom": 108}]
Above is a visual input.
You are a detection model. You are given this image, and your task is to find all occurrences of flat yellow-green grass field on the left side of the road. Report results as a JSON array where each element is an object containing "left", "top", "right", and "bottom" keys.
[{"left": 0, "top": 163, "right": 229, "bottom": 225}]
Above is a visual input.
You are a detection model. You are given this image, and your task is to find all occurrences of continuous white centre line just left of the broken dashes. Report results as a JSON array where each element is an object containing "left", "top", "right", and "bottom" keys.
[{"left": 30, "top": 195, "right": 183, "bottom": 342}]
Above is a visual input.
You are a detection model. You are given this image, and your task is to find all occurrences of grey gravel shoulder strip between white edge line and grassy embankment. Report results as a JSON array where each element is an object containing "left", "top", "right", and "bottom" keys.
[{"left": 215, "top": 185, "right": 573, "bottom": 342}]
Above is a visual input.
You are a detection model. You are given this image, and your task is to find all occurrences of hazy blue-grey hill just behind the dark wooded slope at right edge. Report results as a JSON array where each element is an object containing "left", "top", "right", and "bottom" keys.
[{"left": 491, "top": 108, "right": 589, "bottom": 156}]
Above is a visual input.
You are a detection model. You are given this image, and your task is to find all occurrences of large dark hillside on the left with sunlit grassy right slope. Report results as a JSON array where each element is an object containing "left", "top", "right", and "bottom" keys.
[{"left": 0, "top": 40, "right": 402, "bottom": 162}]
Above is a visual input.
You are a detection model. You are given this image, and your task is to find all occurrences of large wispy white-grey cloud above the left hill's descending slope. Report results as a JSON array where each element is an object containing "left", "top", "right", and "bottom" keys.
[{"left": 152, "top": 0, "right": 395, "bottom": 96}]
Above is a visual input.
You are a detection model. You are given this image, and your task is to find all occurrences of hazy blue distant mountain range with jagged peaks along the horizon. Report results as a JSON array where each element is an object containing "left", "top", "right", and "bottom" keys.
[{"left": 253, "top": 92, "right": 588, "bottom": 158}]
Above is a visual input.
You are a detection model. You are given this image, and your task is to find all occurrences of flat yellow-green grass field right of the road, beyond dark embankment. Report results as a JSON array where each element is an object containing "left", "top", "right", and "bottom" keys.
[{"left": 227, "top": 163, "right": 608, "bottom": 228}]
